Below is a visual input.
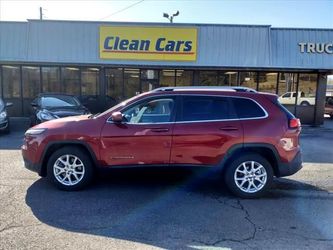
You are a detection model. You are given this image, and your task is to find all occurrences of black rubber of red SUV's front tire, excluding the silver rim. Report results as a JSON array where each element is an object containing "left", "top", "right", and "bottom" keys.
[{"left": 47, "top": 146, "right": 94, "bottom": 191}]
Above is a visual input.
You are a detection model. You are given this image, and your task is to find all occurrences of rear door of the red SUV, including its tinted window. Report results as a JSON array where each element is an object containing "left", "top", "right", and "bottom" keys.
[{"left": 170, "top": 95, "right": 243, "bottom": 165}]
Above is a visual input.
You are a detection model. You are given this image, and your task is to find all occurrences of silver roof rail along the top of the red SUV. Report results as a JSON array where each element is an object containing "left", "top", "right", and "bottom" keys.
[{"left": 153, "top": 86, "right": 257, "bottom": 93}]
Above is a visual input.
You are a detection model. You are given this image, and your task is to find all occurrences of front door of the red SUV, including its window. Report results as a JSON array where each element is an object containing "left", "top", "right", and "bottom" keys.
[{"left": 101, "top": 97, "right": 176, "bottom": 165}]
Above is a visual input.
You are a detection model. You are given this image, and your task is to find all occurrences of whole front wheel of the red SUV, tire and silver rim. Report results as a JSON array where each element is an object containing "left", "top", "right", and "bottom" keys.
[{"left": 47, "top": 146, "right": 94, "bottom": 191}]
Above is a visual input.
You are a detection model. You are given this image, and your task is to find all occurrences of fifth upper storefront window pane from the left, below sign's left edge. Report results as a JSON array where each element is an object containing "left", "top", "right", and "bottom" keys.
[{"left": 81, "top": 68, "right": 99, "bottom": 96}]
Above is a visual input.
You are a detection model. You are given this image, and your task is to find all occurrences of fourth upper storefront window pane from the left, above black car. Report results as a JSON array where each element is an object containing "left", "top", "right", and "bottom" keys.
[{"left": 61, "top": 67, "right": 80, "bottom": 96}]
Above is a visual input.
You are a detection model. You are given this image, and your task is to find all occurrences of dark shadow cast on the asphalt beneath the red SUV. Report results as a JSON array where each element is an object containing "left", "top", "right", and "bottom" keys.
[{"left": 26, "top": 169, "right": 332, "bottom": 249}]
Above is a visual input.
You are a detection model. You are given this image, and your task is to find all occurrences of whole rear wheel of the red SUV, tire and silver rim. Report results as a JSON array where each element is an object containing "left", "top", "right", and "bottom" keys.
[{"left": 224, "top": 153, "right": 273, "bottom": 199}]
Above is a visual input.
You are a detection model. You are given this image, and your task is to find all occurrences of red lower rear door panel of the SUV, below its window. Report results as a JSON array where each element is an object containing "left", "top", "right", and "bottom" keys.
[{"left": 170, "top": 121, "right": 243, "bottom": 165}]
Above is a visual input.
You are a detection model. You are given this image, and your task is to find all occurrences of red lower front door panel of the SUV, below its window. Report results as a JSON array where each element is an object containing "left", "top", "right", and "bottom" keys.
[{"left": 101, "top": 123, "right": 173, "bottom": 165}]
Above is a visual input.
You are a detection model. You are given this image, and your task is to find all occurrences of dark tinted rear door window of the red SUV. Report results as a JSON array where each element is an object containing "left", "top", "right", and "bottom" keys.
[{"left": 177, "top": 96, "right": 236, "bottom": 121}]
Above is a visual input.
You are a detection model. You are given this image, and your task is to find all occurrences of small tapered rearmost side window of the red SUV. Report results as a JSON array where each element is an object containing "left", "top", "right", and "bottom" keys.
[{"left": 232, "top": 98, "right": 266, "bottom": 118}]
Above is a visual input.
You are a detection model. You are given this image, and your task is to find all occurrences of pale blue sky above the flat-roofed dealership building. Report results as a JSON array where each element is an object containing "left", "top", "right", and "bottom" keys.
[{"left": 0, "top": 0, "right": 333, "bottom": 29}]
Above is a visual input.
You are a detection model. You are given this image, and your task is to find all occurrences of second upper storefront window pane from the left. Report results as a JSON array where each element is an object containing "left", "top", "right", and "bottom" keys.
[{"left": 22, "top": 66, "right": 41, "bottom": 98}]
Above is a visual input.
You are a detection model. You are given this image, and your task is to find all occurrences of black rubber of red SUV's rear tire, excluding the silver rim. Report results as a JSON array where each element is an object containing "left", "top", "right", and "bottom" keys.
[{"left": 224, "top": 153, "right": 273, "bottom": 199}]
